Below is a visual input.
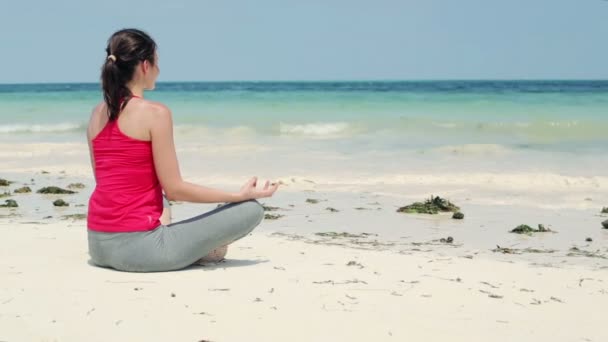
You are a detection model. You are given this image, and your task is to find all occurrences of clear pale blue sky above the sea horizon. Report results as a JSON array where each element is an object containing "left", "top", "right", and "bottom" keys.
[{"left": 0, "top": 0, "right": 608, "bottom": 83}]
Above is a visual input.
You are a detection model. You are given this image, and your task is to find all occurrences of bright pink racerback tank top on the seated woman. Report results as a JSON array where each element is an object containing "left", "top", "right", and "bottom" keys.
[{"left": 87, "top": 120, "right": 163, "bottom": 233}]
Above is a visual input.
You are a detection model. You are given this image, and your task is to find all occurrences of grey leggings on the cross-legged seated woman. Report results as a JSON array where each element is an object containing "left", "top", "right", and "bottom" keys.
[{"left": 88, "top": 200, "right": 264, "bottom": 272}]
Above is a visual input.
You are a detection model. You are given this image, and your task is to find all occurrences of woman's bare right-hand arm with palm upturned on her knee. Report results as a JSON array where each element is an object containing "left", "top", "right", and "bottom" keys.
[{"left": 150, "top": 103, "right": 278, "bottom": 203}]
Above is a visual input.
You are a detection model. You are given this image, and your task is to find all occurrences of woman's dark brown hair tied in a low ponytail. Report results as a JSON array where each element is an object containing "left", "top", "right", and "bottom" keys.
[{"left": 101, "top": 29, "right": 156, "bottom": 120}]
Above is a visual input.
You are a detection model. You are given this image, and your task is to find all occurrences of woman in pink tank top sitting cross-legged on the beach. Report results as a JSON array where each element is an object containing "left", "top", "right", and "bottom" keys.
[{"left": 87, "top": 29, "right": 278, "bottom": 272}]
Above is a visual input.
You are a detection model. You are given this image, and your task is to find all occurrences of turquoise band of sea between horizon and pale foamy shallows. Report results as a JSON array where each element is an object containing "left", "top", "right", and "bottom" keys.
[{"left": 0, "top": 81, "right": 608, "bottom": 150}]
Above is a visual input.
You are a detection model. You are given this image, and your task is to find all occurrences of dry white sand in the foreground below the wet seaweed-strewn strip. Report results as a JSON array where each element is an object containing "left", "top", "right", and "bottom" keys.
[{"left": 0, "top": 222, "right": 608, "bottom": 342}]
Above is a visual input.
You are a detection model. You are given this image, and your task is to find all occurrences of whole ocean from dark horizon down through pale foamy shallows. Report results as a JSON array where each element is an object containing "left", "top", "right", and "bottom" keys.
[{"left": 0, "top": 81, "right": 608, "bottom": 178}]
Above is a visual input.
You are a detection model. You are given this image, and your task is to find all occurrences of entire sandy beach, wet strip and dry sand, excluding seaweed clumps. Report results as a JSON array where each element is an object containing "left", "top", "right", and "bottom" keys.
[{"left": 0, "top": 137, "right": 608, "bottom": 342}]
